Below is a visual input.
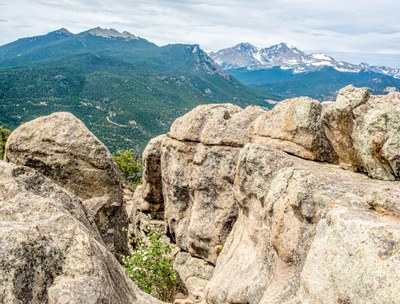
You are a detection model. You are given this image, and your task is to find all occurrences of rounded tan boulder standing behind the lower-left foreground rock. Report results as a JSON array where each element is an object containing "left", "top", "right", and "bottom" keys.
[{"left": 5, "top": 113, "right": 128, "bottom": 253}]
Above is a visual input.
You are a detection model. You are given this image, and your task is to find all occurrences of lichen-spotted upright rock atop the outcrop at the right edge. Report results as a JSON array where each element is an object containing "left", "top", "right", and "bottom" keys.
[{"left": 324, "top": 86, "right": 400, "bottom": 180}]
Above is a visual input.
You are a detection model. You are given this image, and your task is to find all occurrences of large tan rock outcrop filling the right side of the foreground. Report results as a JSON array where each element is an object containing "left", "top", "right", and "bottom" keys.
[{"left": 138, "top": 86, "right": 400, "bottom": 304}]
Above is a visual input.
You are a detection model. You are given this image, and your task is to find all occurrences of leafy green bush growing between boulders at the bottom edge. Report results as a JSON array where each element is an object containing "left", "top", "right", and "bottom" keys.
[{"left": 122, "top": 228, "right": 179, "bottom": 302}]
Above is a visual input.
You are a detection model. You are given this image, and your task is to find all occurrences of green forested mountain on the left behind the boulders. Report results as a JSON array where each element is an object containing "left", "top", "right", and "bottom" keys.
[{"left": 0, "top": 28, "right": 270, "bottom": 150}]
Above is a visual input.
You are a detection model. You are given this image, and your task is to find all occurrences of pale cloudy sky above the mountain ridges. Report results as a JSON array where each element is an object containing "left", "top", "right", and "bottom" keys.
[{"left": 0, "top": 0, "right": 400, "bottom": 68}]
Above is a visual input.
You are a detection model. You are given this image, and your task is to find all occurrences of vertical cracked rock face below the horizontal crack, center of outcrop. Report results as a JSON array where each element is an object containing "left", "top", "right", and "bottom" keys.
[{"left": 161, "top": 138, "right": 239, "bottom": 264}]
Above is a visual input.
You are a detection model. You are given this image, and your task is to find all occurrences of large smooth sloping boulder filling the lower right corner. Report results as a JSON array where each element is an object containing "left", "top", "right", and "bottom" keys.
[{"left": 207, "top": 144, "right": 400, "bottom": 303}]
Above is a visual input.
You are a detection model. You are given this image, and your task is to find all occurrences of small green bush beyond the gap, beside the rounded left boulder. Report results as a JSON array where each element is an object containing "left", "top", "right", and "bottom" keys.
[{"left": 113, "top": 149, "right": 142, "bottom": 187}]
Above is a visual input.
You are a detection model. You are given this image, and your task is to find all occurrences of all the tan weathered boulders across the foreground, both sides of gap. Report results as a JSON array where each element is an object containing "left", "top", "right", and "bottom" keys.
[{"left": 0, "top": 87, "right": 400, "bottom": 304}]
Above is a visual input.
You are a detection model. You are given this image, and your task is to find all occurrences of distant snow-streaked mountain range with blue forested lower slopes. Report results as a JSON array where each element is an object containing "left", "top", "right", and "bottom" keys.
[{"left": 210, "top": 43, "right": 400, "bottom": 100}]
